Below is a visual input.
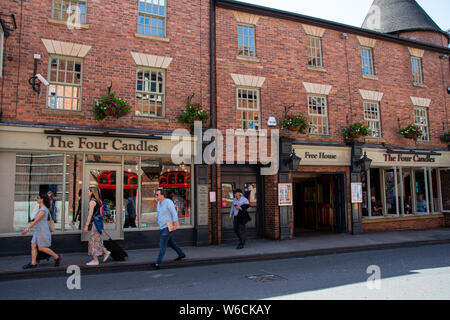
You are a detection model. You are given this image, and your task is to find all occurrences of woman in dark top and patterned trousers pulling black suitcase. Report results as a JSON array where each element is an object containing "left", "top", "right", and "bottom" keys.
[{"left": 84, "top": 187, "right": 111, "bottom": 266}]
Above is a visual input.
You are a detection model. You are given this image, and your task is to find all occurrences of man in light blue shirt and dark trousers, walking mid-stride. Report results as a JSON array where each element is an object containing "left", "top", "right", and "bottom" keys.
[{"left": 153, "top": 189, "right": 186, "bottom": 269}]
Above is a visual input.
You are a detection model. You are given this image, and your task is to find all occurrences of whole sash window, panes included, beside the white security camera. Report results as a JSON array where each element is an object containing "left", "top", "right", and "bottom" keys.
[{"left": 47, "top": 57, "right": 83, "bottom": 111}]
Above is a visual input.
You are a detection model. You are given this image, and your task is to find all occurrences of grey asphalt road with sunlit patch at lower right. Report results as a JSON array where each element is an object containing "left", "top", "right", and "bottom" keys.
[{"left": 0, "top": 244, "right": 450, "bottom": 300}]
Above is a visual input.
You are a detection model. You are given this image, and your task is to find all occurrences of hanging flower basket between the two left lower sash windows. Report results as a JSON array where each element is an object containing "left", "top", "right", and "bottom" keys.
[{"left": 93, "top": 92, "right": 131, "bottom": 120}]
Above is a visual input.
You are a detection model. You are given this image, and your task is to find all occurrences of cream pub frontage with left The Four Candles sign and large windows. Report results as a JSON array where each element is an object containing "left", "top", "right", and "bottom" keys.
[{"left": 0, "top": 125, "right": 208, "bottom": 255}]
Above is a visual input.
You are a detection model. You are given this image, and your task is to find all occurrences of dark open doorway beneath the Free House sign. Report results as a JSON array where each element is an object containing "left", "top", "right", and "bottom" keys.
[{"left": 293, "top": 174, "right": 347, "bottom": 236}]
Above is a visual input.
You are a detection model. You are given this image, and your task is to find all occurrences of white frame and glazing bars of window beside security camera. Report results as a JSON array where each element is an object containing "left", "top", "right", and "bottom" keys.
[{"left": 45, "top": 55, "right": 84, "bottom": 111}]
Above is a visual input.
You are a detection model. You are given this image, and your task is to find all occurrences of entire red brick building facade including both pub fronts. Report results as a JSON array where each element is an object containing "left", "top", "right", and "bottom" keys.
[{"left": 0, "top": 0, "right": 450, "bottom": 254}]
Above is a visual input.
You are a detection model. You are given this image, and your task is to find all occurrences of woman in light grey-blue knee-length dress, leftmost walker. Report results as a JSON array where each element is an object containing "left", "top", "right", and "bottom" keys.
[{"left": 22, "top": 193, "right": 62, "bottom": 269}]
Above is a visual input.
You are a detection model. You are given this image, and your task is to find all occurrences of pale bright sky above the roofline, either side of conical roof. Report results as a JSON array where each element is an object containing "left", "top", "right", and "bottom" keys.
[{"left": 237, "top": 0, "right": 450, "bottom": 31}]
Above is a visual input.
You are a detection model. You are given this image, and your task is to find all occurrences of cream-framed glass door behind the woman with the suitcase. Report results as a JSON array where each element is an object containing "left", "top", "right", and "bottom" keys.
[{"left": 81, "top": 164, "right": 124, "bottom": 241}]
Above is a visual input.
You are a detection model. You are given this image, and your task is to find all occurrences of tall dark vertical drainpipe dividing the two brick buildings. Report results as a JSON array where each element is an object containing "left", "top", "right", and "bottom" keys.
[{"left": 209, "top": 0, "right": 218, "bottom": 244}]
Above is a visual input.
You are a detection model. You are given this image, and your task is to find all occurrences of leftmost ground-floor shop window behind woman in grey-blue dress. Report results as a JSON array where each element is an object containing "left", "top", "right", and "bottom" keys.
[{"left": 13, "top": 153, "right": 64, "bottom": 232}]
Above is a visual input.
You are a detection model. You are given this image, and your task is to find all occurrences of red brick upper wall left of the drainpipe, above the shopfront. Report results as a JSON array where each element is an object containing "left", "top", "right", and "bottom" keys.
[{"left": 0, "top": 0, "right": 210, "bottom": 130}]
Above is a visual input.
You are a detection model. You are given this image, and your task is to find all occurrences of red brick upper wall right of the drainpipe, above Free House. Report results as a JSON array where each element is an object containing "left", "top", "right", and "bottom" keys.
[{"left": 216, "top": 8, "right": 450, "bottom": 147}]
